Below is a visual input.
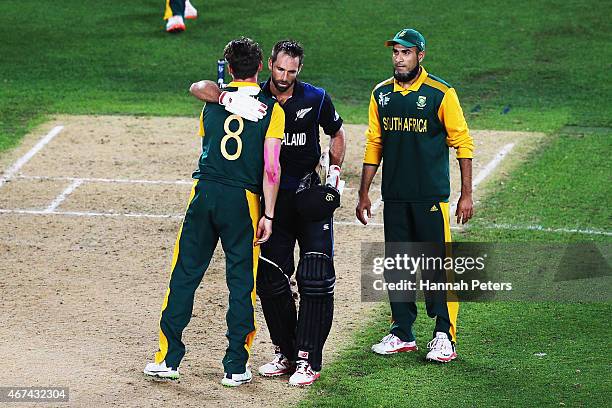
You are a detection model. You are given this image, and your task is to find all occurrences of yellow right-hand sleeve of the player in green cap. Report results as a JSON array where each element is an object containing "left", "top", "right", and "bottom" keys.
[{"left": 438, "top": 88, "right": 474, "bottom": 159}]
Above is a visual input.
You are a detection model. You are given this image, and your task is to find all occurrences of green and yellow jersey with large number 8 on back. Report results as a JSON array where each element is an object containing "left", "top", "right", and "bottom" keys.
[{"left": 193, "top": 82, "right": 285, "bottom": 194}]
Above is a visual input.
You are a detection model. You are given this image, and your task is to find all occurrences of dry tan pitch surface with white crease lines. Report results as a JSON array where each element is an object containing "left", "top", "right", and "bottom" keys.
[{"left": 0, "top": 116, "right": 542, "bottom": 407}]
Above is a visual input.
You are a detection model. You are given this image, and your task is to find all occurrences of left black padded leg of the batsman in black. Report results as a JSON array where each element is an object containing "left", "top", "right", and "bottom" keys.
[{"left": 257, "top": 190, "right": 297, "bottom": 361}]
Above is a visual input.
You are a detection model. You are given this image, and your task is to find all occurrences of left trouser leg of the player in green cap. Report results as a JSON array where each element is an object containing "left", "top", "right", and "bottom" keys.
[{"left": 383, "top": 202, "right": 417, "bottom": 342}]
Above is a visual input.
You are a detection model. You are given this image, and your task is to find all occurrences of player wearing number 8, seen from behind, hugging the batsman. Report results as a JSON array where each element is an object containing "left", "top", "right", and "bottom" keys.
[{"left": 144, "top": 37, "right": 285, "bottom": 386}]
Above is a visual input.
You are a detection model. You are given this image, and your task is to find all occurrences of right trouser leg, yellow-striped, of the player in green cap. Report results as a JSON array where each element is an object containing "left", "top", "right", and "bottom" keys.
[{"left": 412, "top": 202, "right": 459, "bottom": 342}]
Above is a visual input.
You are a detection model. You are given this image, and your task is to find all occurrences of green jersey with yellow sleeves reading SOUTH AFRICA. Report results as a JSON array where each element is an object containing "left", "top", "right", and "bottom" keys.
[{"left": 364, "top": 68, "right": 474, "bottom": 202}]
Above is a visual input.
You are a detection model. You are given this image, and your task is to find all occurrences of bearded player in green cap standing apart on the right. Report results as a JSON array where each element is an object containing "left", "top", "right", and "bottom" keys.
[{"left": 356, "top": 29, "right": 474, "bottom": 362}]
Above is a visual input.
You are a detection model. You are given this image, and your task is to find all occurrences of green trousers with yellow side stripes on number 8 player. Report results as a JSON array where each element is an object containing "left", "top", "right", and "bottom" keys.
[{"left": 155, "top": 180, "right": 260, "bottom": 374}]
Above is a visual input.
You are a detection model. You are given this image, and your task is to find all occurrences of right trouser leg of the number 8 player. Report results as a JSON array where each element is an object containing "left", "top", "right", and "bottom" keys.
[{"left": 213, "top": 183, "right": 260, "bottom": 374}]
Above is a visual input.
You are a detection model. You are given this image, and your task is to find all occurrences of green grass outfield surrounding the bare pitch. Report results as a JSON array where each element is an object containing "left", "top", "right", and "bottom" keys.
[{"left": 0, "top": 0, "right": 612, "bottom": 407}]
